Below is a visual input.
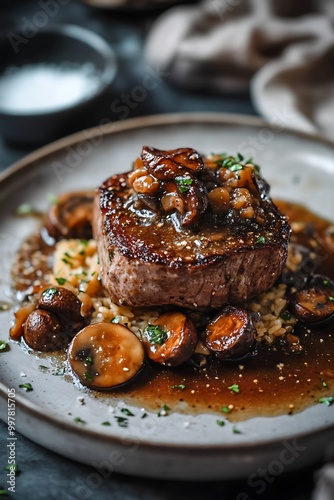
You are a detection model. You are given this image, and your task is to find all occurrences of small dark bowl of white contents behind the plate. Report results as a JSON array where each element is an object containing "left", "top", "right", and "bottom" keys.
[{"left": 0, "top": 25, "right": 117, "bottom": 146}]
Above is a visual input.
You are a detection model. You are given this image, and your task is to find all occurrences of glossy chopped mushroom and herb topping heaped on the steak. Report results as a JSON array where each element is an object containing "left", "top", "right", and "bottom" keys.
[{"left": 128, "top": 146, "right": 264, "bottom": 226}]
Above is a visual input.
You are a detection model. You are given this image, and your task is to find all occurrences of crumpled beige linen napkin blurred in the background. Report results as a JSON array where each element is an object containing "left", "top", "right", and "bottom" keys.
[{"left": 146, "top": 0, "right": 334, "bottom": 139}]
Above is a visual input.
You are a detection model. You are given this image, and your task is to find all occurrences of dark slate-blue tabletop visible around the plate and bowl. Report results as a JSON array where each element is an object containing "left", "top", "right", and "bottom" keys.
[{"left": 0, "top": 0, "right": 328, "bottom": 500}]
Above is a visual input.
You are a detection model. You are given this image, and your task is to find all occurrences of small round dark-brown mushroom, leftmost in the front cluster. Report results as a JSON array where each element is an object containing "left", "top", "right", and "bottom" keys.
[{"left": 23, "top": 309, "right": 72, "bottom": 352}]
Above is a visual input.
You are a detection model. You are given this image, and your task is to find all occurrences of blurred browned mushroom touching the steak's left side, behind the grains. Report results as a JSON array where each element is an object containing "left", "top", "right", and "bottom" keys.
[{"left": 44, "top": 191, "right": 94, "bottom": 240}]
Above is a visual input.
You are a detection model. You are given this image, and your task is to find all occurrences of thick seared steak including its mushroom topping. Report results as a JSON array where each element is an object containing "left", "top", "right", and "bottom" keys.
[{"left": 93, "top": 147, "right": 290, "bottom": 309}]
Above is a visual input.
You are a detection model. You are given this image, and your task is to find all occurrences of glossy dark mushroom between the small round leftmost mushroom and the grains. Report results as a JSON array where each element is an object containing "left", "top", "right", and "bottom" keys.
[{"left": 38, "top": 286, "right": 88, "bottom": 332}]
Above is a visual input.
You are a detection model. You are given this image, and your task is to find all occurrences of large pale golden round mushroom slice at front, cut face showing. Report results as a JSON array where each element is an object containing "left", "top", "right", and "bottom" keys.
[{"left": 68, "top": 323, "right": 145, "bottom": 390}]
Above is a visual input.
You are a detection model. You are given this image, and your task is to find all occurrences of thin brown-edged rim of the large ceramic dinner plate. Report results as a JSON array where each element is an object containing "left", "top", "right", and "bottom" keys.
[{"left": 0, "top": 112, "right": 334, "bottom": 454}]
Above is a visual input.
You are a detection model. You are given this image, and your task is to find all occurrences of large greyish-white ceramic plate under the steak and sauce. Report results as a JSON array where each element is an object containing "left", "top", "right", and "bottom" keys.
[{"left": 0, "top": 114, "right": 334, "bottom": 480}]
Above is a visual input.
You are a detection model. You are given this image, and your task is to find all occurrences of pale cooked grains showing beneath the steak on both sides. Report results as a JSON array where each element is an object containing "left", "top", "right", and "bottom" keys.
[{"left": 50, "top": 239, "right": 302, "bottom": 344}]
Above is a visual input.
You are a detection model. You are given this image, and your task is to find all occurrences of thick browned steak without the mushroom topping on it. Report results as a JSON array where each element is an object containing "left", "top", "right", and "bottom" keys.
[{"left": 93, "top": 149, "right": 290, "bottom": 309}]
